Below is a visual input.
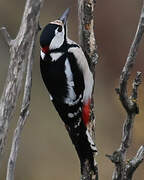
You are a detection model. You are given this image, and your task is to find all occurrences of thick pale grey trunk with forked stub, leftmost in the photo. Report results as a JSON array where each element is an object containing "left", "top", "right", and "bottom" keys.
[{"left": 0, "top": 0, "right": 43, "bottom": 165}]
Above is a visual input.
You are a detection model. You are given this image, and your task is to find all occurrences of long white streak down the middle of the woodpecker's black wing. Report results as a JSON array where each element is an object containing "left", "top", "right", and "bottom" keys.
[{"left": 65, "top": 59, "right": 76, "bottom": 105}]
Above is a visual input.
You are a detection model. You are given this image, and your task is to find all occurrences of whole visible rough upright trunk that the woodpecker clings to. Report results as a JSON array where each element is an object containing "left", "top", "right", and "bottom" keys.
[{"left": 78, "top": 0, "right": 98, "bottom": 180}]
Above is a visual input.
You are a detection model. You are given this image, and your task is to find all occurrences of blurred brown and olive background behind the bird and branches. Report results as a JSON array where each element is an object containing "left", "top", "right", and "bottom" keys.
[{"left": 0, "top": 0, "right": 144, "bottom": 180}]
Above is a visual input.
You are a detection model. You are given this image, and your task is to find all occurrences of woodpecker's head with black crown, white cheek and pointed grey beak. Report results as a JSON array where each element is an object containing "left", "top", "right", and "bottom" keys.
[{"left": 40, "top": 8, "right": 69, "bottom": 54}]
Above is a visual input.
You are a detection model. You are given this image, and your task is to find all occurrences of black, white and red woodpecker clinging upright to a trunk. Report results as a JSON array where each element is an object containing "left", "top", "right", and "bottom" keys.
[{"left": 40, "top": 9, "right": 97, "bottom": 170}]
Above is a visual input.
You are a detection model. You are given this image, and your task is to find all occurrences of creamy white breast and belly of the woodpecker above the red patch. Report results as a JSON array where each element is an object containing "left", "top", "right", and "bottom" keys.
[{"left": 68, "top": 47, "right": 94, "bottom": 102}]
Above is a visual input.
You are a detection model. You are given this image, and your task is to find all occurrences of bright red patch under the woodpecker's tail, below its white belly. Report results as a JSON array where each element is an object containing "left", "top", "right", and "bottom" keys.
[{"left": 82, "top": 99, "right": 91, "bottom": 126}]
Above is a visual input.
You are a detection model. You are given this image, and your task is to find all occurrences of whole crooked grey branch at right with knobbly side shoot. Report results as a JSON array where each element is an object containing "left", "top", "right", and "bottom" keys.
[{"left": 107, "top": 1, "right": 144, "bottom": 180}]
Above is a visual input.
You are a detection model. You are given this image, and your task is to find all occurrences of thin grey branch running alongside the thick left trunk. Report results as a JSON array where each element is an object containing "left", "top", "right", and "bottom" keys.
[{"left": 6, "top": 20, "right": 35, "bottom": 180}]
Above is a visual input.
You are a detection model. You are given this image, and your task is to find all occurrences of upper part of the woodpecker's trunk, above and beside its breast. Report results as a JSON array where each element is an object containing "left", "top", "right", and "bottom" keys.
[{"left": 78, "top": 0, "right": 98, "bottom": 71}]
